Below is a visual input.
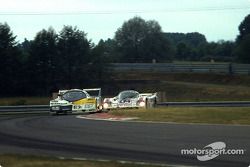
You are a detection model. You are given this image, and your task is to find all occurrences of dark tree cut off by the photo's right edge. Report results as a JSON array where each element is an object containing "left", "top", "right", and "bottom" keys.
[{"left": 235, "top": 14, "right": 250, "bottom": 63}]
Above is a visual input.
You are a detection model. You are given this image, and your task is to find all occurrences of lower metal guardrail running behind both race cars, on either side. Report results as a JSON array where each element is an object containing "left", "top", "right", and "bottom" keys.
[{"left": 0, "top": 101, "right": 250, "bottom": 113}]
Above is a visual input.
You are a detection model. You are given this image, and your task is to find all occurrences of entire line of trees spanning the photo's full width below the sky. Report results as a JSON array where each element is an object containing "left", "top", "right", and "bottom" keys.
[{"left": 0, "top": 15, "right": 250, "bottom": 96}]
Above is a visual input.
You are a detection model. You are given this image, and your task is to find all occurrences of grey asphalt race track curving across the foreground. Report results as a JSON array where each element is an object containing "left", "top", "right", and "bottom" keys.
[{"left": 0, "top": 115, "right": 250, "bottom": 167}]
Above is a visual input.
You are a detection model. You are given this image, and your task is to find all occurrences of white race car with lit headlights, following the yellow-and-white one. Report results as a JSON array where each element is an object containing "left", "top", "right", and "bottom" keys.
[{"left": 103, "top": 90, "right": 157, "bottom": 110}]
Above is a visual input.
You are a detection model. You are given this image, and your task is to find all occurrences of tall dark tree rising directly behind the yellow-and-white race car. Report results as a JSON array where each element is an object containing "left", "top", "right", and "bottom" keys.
[{"left": 58, "top": 26, "right": 90, "bottom": 88}]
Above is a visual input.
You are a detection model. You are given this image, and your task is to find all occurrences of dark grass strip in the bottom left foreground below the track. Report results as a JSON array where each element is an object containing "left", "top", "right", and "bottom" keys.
[{"left": 0, "top": 155, "right": 163, "bottom": 167}]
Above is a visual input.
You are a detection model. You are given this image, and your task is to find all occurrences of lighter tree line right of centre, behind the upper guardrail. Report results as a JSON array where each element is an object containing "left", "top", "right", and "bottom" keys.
[{"left": 95, "top": 15, "right": 250, "bottom": 63}]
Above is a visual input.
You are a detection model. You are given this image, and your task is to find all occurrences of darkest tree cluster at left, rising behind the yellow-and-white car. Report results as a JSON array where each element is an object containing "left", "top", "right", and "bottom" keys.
[{"left": 0, "top": 23, "right": 107, "bottom": 96}]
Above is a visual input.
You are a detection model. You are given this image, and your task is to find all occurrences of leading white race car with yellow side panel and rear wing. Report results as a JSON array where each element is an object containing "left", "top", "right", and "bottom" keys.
[{"left": 50, "top": 88, "right": 102, "bottom": 114}]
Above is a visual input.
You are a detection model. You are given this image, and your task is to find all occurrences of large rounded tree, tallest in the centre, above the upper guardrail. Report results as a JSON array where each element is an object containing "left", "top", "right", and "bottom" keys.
[{"left": 115, "top": 17, "right": 170, "bottom": 62}]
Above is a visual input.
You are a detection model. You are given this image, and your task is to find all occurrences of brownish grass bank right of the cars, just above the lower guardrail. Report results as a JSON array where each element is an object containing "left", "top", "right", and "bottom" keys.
[{"left": 157, "top": 81, "right": 250, "bottom": 101}]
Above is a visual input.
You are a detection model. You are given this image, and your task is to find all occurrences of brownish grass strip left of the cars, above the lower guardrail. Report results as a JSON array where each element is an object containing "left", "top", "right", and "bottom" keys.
[{"left": 0, "top": 97, "right": 51, "bottom": 106}]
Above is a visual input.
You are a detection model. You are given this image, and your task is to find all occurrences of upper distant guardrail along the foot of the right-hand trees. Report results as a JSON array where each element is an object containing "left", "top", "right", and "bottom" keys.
[{"left": 112, "top": 63, "right": 250, "bottom": 75}]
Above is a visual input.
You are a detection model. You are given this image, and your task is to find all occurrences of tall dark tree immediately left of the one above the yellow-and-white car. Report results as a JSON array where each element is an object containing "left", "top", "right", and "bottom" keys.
[{"left": 26, "top": 28, "right": 59, "bottom": 95}]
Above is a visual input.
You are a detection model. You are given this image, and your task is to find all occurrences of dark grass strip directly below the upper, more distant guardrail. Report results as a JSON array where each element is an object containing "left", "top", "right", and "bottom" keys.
[{"left": 113, "top": 71, "right": 250, "bottom": 86}]
